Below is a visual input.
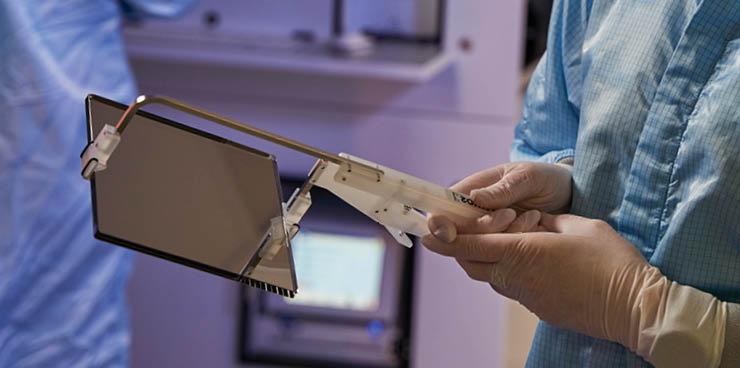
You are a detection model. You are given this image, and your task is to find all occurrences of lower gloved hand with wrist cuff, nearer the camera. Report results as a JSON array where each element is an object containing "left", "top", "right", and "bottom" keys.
[{"left": 422, "top": 214, "right": 726, "bottom": 367}]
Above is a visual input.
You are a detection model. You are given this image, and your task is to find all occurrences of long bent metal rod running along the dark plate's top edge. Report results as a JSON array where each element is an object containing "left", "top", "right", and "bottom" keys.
[{"left": 116, "top": 95, "right": 360, "bottom": 167}]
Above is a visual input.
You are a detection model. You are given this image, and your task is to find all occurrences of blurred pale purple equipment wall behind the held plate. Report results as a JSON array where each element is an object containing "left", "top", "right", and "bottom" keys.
[{"left": 114, "top": 0, "right": 536, "bottom": 367}]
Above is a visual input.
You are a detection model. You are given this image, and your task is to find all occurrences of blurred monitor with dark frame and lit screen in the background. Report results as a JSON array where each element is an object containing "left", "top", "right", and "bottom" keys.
[{"left": 240, "top": 179, "right": 414, "bottom": 367}]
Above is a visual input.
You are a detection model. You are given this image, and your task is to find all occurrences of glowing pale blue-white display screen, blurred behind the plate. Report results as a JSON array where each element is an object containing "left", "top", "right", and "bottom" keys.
[{"left": 285, "top": 230, "right": 385, "bottom": 311}]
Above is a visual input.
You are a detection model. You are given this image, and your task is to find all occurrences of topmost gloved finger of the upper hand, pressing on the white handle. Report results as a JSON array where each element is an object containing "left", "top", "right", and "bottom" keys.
[{"left": 470, "top": 171, "right": 539, "bottom": 208}]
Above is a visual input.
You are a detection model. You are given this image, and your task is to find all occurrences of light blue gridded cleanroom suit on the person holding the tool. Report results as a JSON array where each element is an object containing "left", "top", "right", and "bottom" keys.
[{"left": 512, "top": 0, "right": 740, "bottom": 368}]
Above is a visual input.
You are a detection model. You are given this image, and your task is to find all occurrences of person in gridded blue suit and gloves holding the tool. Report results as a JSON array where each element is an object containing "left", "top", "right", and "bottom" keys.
[{"left": 422, "top": 0, "right": 740, "bottom": 367}]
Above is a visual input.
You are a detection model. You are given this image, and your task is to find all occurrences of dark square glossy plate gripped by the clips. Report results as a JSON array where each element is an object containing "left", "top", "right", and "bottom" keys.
[{"left": 87, "top": 95, "right": 297, "bottom": 296}]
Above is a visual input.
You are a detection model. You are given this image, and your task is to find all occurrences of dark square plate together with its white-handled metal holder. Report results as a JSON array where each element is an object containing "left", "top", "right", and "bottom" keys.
[{"left": 81, "top": 95, "right": 488, "bottom": 297}]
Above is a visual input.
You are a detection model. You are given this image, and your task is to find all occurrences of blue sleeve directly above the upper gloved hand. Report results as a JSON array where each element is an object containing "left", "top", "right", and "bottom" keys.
[{"left": 510, "top": 0, "right": 586, "bottom": 163}]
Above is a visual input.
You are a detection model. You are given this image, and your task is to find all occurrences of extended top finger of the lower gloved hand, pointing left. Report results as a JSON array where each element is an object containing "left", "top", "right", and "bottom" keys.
[{"left": 421, "top": 234, "right": 528, "bottom": 262}]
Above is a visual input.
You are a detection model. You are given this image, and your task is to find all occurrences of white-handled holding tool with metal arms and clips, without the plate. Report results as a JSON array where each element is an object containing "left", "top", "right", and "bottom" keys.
[{"left": 81, "top": 96, "right": 498, "bottom": 252}]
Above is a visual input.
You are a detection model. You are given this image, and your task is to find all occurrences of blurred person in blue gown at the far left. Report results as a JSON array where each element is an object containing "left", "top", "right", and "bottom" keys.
[{"left": 0, "top": 0, "right": 192, "bottom": 367}]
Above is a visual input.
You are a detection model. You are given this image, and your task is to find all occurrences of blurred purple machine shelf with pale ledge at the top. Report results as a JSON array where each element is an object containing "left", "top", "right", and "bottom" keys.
[{"left": 123, "top": 0, "right": 452, "bottom": 82}]
